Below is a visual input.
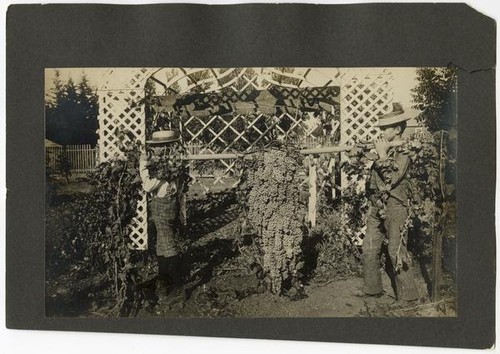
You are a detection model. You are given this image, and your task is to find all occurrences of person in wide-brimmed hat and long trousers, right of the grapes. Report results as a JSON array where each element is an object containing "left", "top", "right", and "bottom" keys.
[{"left": 362, "top": 103, "right": 419, "bottom": 302}]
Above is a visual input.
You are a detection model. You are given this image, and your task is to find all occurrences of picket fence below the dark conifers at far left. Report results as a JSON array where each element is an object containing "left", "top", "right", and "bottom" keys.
[{"left": 45, "top": 144, "right": 96, "bottom": 176}]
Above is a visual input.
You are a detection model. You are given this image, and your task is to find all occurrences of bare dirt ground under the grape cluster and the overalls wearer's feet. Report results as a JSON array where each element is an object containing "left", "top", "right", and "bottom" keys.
[{"left": 138, "top": 220, "right": 456, "bottom": 318}]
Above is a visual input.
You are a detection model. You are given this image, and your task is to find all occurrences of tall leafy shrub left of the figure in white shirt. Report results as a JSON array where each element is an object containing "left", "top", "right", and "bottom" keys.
[{"left": 48, "top": 137, "right": 154, "bottom": 316}]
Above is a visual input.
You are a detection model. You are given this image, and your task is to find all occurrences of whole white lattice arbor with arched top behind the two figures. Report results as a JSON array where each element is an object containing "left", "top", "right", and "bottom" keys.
[{"left": 99, "top": 68, "right": 392, "bottom": 249}]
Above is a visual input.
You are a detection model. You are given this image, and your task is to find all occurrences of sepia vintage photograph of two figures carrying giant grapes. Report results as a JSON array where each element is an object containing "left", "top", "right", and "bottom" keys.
[{"left": 45, "top": 66, "right": 460, "bottom": 318}]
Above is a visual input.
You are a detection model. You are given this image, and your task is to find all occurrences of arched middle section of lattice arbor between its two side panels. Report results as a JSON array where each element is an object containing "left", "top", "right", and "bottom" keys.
[{"left": 151, "top": 68, "right": 340, "bottom": 191}]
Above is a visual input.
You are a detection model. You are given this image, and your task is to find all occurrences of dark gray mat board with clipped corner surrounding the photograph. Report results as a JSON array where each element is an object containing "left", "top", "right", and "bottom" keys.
[{"left": 6, "top": 4, "right": 496, "bottom": 348}]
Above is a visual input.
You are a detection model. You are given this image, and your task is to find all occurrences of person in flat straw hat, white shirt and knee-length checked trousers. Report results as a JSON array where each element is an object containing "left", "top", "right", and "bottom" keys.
[{"left": 139, "top": 130, "right": 184, "bottom": 300}]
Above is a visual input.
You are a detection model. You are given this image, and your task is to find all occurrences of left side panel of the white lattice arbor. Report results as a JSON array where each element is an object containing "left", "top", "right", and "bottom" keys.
[{"left": 99, "top": 68, "right": 159, "bottom": 250}]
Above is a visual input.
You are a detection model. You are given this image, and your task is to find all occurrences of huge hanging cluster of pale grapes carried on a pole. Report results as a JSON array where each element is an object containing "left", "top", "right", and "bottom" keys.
[{"left": 247, "top": 150, "right": 306, "bottom": 294}]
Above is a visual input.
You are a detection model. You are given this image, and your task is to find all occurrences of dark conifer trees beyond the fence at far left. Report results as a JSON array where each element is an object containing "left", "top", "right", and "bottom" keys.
[{"left": 45, "top": 71, "right": 99, "bottom": 146}]
